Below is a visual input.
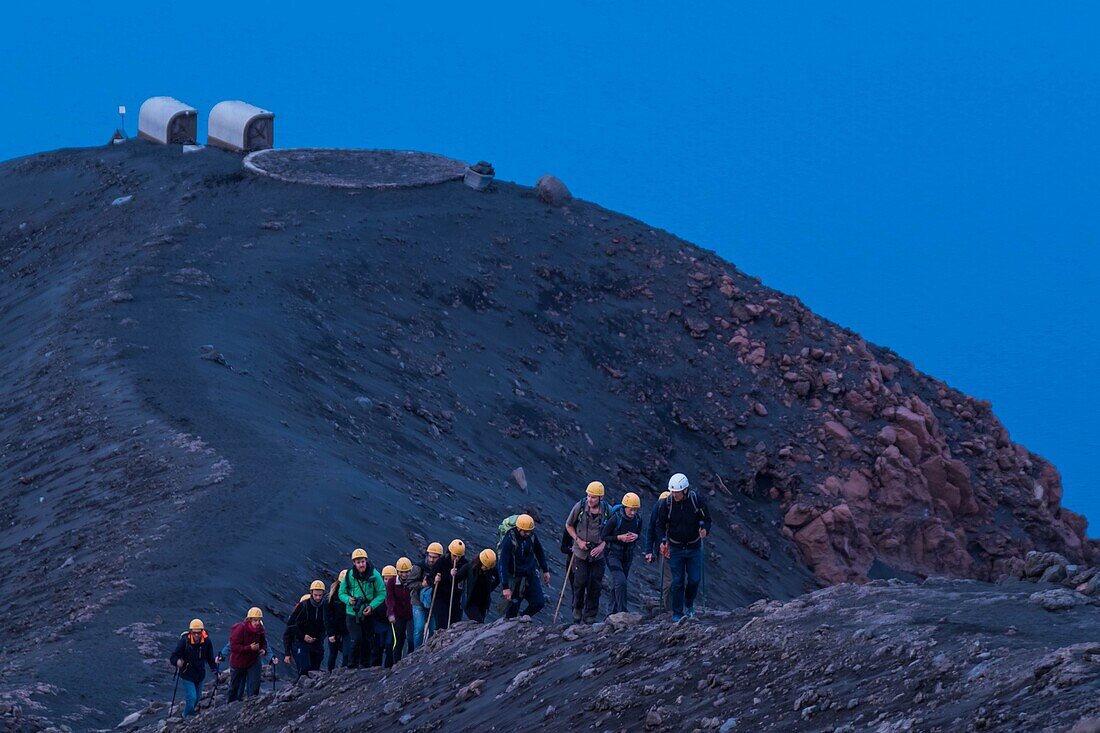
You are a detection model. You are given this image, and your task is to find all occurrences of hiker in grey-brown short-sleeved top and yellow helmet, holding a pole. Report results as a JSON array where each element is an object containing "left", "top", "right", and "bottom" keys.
[{"left": 565, "top": 481, "right": 609, "bottom": 624}]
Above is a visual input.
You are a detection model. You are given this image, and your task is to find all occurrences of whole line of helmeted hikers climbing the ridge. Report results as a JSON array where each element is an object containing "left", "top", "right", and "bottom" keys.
[{"left": 169, "top": 473, "right": 711, "bottom": 716}]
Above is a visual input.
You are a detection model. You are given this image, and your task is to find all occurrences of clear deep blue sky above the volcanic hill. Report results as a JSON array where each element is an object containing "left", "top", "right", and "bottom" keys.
[{"left": 0, "top": 0, "right": 1100, "bottom": 528}]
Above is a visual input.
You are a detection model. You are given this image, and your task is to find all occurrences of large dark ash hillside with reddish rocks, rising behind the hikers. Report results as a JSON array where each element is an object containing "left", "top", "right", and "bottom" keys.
[{"left": 0, "top": 143, "right": 1092, "bottom": 725}]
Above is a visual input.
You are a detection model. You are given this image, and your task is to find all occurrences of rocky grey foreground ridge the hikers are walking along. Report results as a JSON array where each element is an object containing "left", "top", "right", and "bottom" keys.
[{"left": 137, "top": 580, "right": 1100, "bottom": 733}]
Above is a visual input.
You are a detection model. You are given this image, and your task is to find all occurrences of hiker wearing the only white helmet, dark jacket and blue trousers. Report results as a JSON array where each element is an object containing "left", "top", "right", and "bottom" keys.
[{"left": 657, "top": 473, "right": 711, "bottom": 621}]
